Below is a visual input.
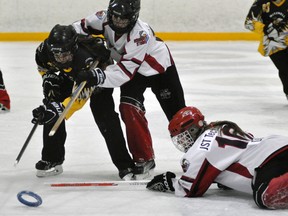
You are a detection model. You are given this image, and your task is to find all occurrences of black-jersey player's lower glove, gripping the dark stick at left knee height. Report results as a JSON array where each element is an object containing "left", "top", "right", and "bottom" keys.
[{"left": 32, "top": 102, "right": 64, "bottom": 125}]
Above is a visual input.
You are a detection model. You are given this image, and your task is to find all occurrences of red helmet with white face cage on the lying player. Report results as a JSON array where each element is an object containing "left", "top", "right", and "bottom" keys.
[{"left": 168, "top": 106, "right": 205, "bottom": 152}]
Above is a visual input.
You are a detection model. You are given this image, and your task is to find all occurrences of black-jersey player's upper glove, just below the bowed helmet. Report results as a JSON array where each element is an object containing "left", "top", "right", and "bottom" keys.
[{"left": 42, "top": 73, "right": 62, "bottom": 101}]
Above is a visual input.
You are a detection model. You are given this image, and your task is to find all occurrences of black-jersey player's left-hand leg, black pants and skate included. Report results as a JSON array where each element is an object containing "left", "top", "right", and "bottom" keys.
[{"left": 35, "top": 121, "right": 67, "bottom": 177}]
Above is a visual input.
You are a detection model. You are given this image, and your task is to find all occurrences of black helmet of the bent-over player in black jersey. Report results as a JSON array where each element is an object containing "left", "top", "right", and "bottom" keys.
[{"left": 46, "top": 24, "right": 78, "bottom": 67}]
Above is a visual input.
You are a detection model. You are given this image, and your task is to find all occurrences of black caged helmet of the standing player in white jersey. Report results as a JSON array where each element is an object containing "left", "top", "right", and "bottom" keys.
[{"left": 107, "top": 0, "right": 140, "bottom": 34}]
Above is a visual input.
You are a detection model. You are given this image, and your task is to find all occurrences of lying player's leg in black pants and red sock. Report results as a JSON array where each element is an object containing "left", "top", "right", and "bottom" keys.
[{"left": 252, "top": 151, "right": 288, "bottom": 209}]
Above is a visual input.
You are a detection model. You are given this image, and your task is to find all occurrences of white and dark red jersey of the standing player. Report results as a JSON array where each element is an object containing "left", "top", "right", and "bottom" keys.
[{"left": 73, "top": 10, "right": 174, "bottom": 88}]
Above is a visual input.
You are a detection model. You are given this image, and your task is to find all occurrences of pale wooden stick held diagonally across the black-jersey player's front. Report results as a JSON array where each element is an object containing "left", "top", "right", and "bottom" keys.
[{"left": 49, "top": 81, "right": 86, "bottom": 136}]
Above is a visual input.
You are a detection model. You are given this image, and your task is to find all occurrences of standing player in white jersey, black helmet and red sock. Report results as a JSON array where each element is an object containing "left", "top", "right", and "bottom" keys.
[{"left": 73, "top": 0, "right": 185, "bottom": 174}]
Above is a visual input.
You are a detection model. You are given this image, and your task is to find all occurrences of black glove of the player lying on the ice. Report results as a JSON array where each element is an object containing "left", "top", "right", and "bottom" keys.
[{"left": 146, "top": 172, "right": 176, "bottom": 192}]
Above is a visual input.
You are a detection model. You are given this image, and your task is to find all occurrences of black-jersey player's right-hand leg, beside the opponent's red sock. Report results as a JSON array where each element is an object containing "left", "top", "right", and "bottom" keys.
[{"left": 90, "top": 88, "right": 134, "bottom": 180}]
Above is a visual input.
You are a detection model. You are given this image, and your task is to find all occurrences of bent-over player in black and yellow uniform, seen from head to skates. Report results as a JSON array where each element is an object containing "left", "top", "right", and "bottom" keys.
[{"left": 32, "top": 24, "right": 134, "bottom": 180}]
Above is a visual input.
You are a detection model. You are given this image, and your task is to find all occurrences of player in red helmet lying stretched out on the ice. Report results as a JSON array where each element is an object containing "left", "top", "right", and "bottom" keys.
[{"left": 147, "top": 107, "right": 288, "bottom": 209}]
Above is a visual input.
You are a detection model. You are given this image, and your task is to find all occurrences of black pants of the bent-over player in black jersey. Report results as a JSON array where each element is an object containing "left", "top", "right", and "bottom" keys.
[{"left": 42, "top": 88, "right": 134, "bottom": 170}]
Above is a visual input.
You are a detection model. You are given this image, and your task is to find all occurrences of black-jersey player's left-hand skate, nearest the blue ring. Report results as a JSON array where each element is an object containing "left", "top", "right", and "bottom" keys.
[{"left": 35, "top": 160, "right": 63, "bottom": 177}]
